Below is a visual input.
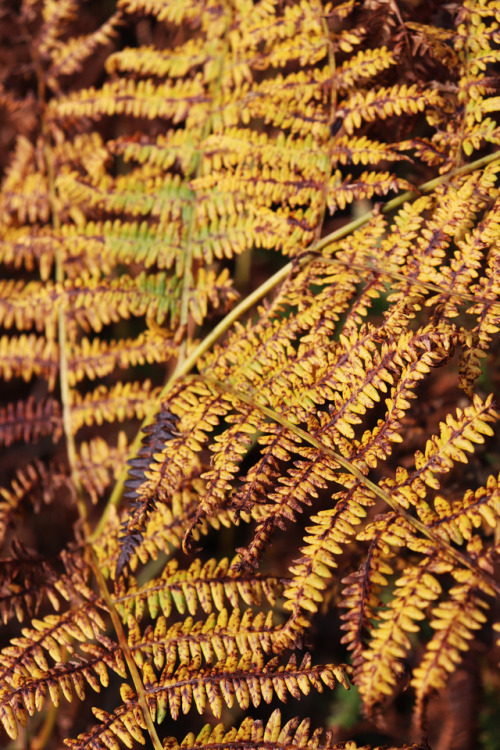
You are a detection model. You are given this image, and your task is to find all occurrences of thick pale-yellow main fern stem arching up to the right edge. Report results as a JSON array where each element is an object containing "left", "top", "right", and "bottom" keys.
[{"left": 91, "top": 145, "right": 500, "bottom": 540}]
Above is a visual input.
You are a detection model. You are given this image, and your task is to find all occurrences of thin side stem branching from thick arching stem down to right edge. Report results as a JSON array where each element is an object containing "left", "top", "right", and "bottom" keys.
[{"left": 199, "top": 375, "right": 500, "bottom": 594}]
